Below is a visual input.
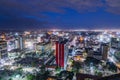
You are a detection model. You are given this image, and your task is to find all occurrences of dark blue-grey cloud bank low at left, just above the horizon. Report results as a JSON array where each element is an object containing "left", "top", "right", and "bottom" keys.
[{"left": 0, "top": 12, "right": 48, "bottom": 29}]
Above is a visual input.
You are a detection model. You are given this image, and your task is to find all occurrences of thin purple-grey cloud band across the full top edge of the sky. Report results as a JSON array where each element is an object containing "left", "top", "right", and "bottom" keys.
[{"left": 0, "top": 0, "right": 120, "bottom": 15}]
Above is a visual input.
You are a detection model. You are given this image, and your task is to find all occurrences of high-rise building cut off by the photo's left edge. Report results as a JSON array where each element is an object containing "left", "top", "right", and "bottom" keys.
[{"left": 0, "top": 41, "right": 8, "bottom": 59}]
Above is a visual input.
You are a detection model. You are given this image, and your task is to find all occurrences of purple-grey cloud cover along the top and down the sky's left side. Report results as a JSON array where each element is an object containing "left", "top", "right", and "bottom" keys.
[{"left": 0, "top": 0, "right": 120, "bottom": 26}]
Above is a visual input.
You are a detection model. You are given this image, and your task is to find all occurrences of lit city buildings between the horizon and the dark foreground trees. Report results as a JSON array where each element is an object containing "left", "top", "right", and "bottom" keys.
[{"left": 0, "top": 31, "right": 120, "bottom": 79}]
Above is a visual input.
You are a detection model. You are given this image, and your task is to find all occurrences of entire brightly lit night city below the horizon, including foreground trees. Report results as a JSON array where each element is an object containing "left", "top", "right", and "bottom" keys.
[{"left": 0, "top": 30, "right": 120, "bottom": 80}]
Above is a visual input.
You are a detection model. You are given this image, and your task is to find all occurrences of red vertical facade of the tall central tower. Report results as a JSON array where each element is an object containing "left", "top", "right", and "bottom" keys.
[{"left": 56, "top": 41, "right": 64, "bottom": 67}]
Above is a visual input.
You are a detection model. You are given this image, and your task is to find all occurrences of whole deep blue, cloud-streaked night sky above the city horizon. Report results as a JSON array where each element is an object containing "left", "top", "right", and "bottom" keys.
[{"left": 0, "top": 0, "right": 120, "bottom": 29}]
